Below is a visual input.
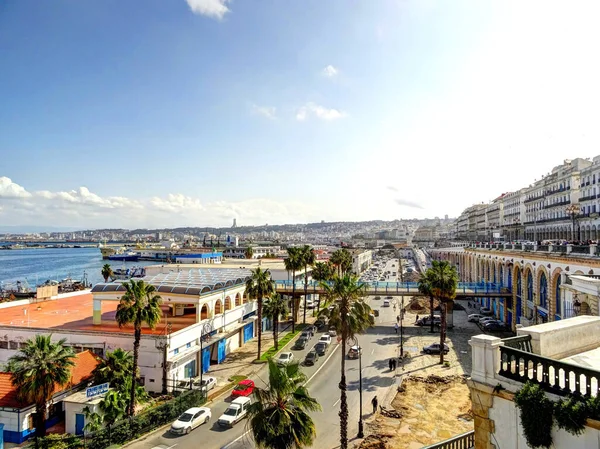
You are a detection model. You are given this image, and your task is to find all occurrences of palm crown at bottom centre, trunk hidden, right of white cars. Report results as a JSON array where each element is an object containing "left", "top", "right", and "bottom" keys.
[{"left": 248, "top": 360, "right": 321, "bottom": 449}]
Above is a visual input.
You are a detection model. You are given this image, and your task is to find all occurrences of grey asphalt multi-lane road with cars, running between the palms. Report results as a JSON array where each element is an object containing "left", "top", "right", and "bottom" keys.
[{"left": 130, "top": 280, "right": 398, "bottom": 449}]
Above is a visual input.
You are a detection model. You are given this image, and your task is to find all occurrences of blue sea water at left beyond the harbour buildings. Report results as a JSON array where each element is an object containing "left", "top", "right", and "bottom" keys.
[{"left": 0, "top": 247, "right": 163, "bottom": 288}]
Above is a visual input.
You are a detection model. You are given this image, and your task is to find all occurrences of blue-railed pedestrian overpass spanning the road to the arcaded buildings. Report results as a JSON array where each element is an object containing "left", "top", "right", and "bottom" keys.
[{"left": 274, "top": 281, "right": 512, "bottom": 298}]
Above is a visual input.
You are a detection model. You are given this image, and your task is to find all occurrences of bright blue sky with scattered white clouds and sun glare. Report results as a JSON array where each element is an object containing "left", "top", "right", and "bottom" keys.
[{"left": 0, "top": 0, "right": 600, "bottom": 229}]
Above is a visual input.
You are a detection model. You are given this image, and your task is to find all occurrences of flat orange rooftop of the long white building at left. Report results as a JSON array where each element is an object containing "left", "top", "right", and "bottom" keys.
[{"left": 0, "top": 293, "right": 196, "bottom": 335}]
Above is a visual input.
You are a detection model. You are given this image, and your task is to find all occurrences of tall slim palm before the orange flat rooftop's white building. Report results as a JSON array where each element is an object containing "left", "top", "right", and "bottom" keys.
[{"left": 115, "top": 279, "right": 162, "bottom": 416}]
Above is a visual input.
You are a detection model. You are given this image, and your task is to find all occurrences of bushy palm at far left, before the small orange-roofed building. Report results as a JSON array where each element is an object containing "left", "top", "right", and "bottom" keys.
[{"left": 7, "top": 335, "right": 75, "bottom": 437}]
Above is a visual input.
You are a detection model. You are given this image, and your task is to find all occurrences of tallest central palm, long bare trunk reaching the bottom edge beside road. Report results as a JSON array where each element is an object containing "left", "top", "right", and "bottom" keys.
[{"left": 319, "top": 274, "right": 374, "bottom": 449}]
